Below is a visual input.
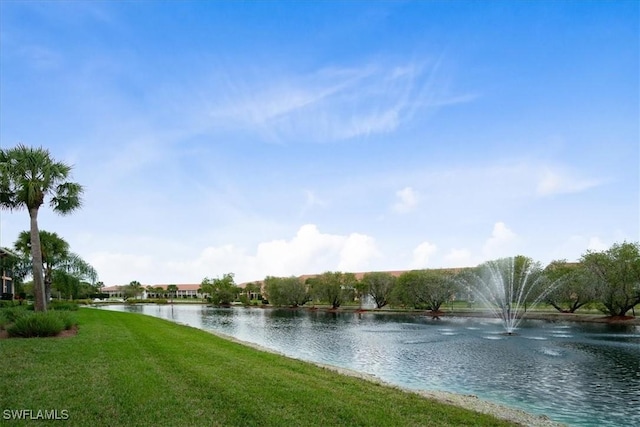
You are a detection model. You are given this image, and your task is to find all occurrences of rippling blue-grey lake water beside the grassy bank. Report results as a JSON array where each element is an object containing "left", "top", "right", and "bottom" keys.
[{"left": 97, "top": 305, "right": 640, "bottom": 426}]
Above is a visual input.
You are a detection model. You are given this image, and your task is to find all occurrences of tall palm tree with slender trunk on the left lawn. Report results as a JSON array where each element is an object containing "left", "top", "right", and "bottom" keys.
[{"left": 0, "top": 144, "right": 83, "bottom": 311}]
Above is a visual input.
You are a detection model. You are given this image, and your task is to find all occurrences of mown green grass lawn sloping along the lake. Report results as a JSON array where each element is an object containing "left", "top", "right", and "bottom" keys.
[{"left": 0, "top": 308, "right": 510, "bottom": 426}]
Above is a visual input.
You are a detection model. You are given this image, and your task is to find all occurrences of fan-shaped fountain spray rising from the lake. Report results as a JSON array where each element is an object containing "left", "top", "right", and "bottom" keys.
[{"left": 465, "top": 256, "right": 555, "bottom": 335}]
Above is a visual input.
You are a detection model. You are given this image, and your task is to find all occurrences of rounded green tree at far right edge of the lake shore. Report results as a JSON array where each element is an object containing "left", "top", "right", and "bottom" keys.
[{"left": 580, "top": 242, "right": 640, "bottom": 316}]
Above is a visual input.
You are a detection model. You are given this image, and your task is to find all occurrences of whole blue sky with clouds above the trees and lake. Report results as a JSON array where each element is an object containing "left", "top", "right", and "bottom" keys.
[{"left": 0, "top": 0, "right": 640, "bottom": 285}]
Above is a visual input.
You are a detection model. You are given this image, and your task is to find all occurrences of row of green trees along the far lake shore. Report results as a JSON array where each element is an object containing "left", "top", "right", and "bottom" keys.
[{"left": 201, "top": 242, "right": 640, "bottom": 316}]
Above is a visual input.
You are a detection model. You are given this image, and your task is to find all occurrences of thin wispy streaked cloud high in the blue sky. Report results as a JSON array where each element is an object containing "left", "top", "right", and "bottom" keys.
[{"left": 210, "top": 58, "right": 475, "bottom": 142}]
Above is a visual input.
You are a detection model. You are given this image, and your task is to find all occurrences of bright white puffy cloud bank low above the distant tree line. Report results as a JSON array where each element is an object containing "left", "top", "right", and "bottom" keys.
[{"left": 93, "top": 224, "right": 381, "bottom": 286}]
